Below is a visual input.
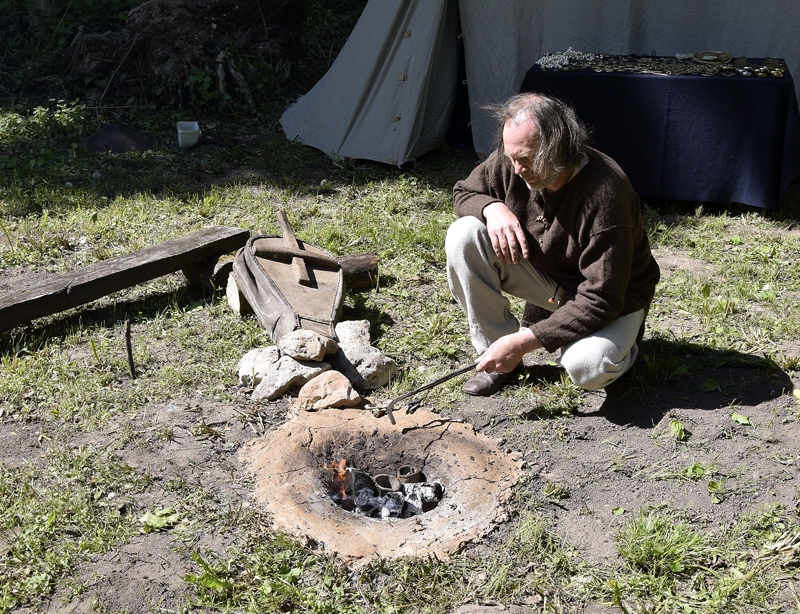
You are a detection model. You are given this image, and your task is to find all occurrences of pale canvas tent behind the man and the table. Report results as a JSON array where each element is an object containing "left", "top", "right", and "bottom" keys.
[{"left": 280, "top": 0, "right": 800, "bottom": 165}]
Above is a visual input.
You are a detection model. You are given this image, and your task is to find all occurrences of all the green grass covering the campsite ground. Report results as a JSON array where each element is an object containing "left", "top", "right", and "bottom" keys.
[{"left": 0, "top": 97, "right": 800, "bottom": 613}]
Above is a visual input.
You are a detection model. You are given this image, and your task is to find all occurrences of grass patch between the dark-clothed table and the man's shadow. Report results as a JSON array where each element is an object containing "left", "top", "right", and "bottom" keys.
[{"left": 650, "top": 207, "right": 800, "bottom": 366}]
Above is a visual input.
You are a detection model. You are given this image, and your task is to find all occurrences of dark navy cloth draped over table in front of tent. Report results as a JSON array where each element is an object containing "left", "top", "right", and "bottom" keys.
[{"left": 521, "top": 60, "right": 800, "bottom": 208}]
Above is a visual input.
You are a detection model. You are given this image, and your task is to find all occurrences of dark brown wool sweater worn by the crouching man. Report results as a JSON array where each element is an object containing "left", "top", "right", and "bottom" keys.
[{"left": 454, "top": 148, "right": 660, "bottom": 352}]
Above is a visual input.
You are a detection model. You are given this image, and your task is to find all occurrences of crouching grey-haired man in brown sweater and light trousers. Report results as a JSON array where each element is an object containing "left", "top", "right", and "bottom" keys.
[{"left": 445, "top": 94, "right": 660, "bottom": 396}]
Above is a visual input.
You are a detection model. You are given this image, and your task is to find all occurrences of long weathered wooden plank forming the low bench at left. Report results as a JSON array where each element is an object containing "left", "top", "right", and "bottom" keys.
[{"left": 0, "top": 226, "right": 250, "bottom": 331}]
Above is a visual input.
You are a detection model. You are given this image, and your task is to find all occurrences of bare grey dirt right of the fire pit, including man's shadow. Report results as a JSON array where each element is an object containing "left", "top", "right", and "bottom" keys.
[{"left": 446, "top": 341, "right": 800, "bottom": 564}]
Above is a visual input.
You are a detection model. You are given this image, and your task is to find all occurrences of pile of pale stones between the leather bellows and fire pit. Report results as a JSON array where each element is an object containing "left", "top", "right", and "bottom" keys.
[{"left": 239, "top": 320, "right": 397, "bottom": 411}]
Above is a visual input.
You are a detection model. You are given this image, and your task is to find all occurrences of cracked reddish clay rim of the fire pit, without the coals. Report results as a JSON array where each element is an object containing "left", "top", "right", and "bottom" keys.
[{"left": 240, "top": 409, "right": 520, "bottom": 563}]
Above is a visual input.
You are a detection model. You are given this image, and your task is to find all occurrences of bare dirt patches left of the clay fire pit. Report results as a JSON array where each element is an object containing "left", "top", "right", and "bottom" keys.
[{"left": 0, "top": 398, "right": 268, "bottom": 614}]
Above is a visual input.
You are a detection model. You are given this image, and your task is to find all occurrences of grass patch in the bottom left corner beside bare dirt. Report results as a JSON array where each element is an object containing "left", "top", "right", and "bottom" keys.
[{"left": 0, "top": 442, "right": 142, "bottom": 612}]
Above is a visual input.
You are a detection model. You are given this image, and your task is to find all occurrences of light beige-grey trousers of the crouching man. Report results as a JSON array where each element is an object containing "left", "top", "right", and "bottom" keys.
[{"left": 445, "top": 216, "right": 645, "bottom": 390}]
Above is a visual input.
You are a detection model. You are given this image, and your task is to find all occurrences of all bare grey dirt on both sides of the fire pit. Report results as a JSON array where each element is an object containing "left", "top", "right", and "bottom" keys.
[{"left": 0, "top": 256, "right": 800, "bottom": 614}]
